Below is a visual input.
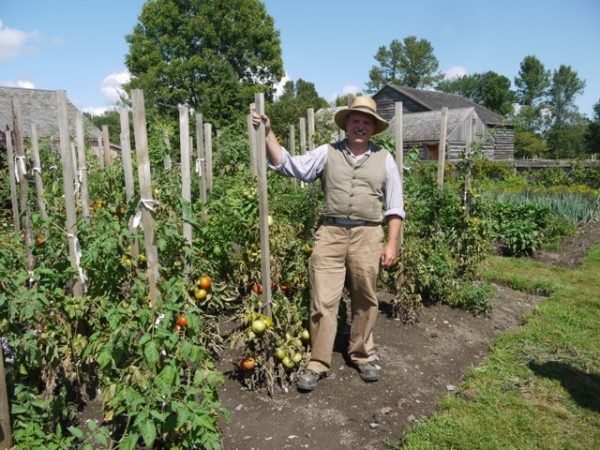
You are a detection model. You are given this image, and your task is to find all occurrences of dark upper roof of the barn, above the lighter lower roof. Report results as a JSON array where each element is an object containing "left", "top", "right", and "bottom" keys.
[{"left": 375, "top": 84, "right": 506, "bottom": 125}]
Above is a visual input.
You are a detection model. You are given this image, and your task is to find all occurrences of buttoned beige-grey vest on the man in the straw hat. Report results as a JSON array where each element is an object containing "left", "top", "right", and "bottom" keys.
[{"left": 321, "top": 141, "right": 388, "bottom": 222}]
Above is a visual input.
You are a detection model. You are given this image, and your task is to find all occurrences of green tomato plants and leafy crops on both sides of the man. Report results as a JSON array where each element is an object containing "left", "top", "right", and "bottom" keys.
[{"left": 0, "top": 95, "right": 600, "bottom": 449}]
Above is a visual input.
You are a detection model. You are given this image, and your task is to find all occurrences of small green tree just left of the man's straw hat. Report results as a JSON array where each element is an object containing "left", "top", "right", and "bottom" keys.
[{"left": 267, "top": 79, "right": 328, "bottom": 139}]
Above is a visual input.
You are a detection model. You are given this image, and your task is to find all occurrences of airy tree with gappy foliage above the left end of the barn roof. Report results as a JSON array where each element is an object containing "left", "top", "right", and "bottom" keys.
[{"left": 366, "top": 36, "right": 443, "bottom": 93}]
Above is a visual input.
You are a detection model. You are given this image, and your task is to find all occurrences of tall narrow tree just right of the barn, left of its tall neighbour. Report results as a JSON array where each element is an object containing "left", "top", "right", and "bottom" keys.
[{"left": 515, "top": 55, "right": 551, "bottom": 133}]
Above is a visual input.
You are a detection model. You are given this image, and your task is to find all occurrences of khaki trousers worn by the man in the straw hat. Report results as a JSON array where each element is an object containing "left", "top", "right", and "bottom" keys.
[{"left": 308, "top": 225, "right": 383, "bottom": 373}]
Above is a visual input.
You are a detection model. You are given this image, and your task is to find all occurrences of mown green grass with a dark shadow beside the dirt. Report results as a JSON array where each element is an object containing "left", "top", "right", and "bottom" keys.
[{"left": 390, "top": 241, "right": 600, "bottom": 450}]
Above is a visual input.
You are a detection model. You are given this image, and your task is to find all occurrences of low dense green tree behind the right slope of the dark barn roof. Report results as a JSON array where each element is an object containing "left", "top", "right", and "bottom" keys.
[{"left": 437, "top": 71, "right": 514, "bottom": 115}]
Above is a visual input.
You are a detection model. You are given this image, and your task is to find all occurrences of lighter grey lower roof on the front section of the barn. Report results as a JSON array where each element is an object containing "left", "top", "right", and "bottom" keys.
[{"left": 390, "top": 107, "right": 477, "bottom": 142}]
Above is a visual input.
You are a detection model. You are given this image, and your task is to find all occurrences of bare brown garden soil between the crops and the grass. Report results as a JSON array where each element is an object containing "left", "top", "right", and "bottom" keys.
[{"left": 220, "top": 222, "right": 600, "bottom": 450}]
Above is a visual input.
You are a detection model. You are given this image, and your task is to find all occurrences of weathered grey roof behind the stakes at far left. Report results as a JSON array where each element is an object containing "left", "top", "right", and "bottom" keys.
[{"left": 0, "top": 86, "right": 101, "bottom": 137}]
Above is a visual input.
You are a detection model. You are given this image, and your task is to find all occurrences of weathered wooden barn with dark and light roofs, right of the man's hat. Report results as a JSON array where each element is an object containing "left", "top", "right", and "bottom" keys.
[{"left": 373, "top": 85, "right": 514, "bottom": 162}]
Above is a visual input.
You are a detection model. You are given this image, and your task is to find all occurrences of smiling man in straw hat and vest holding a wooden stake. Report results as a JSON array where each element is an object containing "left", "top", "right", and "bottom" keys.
[{"left": 252, "top": 96, "right": 405, "bottom": 391}]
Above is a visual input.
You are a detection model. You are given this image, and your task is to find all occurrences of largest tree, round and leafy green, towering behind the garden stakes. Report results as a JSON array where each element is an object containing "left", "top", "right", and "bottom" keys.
[{"left": 125, "top": 0, "right": 283, "bottom": 127}]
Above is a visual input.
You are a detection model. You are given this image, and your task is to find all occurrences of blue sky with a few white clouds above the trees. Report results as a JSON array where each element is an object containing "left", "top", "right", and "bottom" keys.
[{"left": 0, "top": 0, "right": 600, "bottom": 117}]
